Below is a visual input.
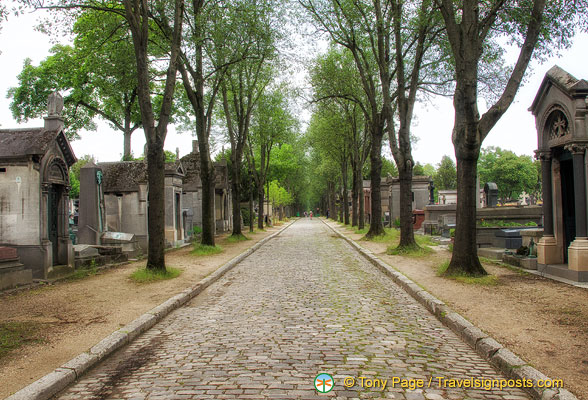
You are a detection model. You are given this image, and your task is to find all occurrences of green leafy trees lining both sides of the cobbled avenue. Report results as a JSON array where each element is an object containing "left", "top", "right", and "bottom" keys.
[{"left": 5, "top": 0, "right": 588, "bottom": 275}]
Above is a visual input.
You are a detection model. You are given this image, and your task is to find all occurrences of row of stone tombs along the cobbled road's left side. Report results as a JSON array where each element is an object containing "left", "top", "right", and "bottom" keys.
[{"left": 0, "top": 93, "right": 232, "bottom": 290}]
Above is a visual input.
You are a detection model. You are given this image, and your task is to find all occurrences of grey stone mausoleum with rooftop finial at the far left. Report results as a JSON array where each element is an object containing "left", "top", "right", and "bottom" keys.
[{"left": 0, "top": 93, "right": 77, "bottom": 279}]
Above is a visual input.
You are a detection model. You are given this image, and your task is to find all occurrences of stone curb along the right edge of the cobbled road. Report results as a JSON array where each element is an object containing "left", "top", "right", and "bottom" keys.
[{"left": 321, "top": 219, "right": 578, "bottom": 400}]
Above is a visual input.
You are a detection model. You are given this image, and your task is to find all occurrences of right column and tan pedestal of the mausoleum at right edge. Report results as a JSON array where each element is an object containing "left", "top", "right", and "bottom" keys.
[{"left": 566, "top": 144, "right": 588, "bottom": 276}]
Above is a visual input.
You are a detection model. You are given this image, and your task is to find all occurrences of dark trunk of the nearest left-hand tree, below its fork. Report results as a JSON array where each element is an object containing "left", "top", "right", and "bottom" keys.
[{"left": 147, "top": 138, "right": 165, "bottom": 271}]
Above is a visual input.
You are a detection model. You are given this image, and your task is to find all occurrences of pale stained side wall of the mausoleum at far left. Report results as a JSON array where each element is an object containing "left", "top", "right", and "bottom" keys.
[{"left": 0, "top": 163, "right": 41, "bottom": 246}]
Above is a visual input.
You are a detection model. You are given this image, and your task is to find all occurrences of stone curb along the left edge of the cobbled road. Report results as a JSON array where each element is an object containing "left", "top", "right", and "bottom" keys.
[{"left": 5, "top": 221, "right": 296, "bottom": 400}]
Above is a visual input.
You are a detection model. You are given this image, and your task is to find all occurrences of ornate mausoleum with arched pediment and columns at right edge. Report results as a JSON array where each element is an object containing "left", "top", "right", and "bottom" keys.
[{"left": 529, "top": 66, "right": 588, "bottom": 281}]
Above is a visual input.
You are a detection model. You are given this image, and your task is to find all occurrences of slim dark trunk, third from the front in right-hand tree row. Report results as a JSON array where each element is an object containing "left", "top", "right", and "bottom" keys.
[{"left": 366, "top": 128, "right": 386, "bottom": 238}]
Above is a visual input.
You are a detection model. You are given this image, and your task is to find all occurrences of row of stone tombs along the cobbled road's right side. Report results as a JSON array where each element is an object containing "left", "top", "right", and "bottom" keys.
[{"left": 337, "top": 66, "right": 588, "bottom": 282}]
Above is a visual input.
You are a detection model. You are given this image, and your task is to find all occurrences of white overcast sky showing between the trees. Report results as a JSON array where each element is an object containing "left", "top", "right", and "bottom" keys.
[{"left": 0, "top": 3, "right": 588, "bottom": 165}]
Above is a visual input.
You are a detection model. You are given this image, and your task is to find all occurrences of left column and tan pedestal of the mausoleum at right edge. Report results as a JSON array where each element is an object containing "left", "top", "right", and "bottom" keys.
[{"left": 536, "top": 150, "right": 563, "bottom": 265}]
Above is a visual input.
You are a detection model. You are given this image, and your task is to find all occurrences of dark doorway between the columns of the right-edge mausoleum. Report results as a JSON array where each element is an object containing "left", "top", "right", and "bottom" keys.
[{"left": 559, "top": 152, "right": 576, "bottom": 263}]
